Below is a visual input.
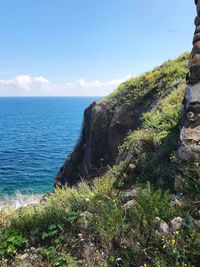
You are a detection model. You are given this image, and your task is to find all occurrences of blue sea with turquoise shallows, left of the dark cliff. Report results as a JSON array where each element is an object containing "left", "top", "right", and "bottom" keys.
[{"left": 0, "top": 97, "right": 100, "bottom": 201}]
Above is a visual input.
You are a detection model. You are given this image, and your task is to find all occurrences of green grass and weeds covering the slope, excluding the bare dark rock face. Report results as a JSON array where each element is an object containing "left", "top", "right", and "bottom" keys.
[{"left": 0, "top": 54, "right": 200, "bottom": 267}]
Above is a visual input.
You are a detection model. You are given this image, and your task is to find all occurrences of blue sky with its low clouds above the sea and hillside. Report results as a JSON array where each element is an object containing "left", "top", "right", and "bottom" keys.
[{"left": 0, "top": 0, "right": 195, "bottom": 96}]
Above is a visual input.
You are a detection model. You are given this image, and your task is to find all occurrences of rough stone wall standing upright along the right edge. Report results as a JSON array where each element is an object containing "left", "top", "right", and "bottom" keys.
[{"left": 178, "top": 0, "right": 200, "bottom": 161}]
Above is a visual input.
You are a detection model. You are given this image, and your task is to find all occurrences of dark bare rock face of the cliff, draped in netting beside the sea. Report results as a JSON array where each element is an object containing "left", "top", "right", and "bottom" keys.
[{"left": 55, "top": 97, "right": 148, "bottom": 186}]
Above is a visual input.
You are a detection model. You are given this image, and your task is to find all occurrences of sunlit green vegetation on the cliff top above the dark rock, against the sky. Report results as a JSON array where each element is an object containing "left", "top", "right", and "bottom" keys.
[{"left": 103, "top": 53, "right": 189, "bottom": 109}]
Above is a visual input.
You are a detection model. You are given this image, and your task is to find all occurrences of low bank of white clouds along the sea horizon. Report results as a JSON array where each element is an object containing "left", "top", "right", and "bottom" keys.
[{"left": 0, "top": 75, "right": 131, "bottom": 96}]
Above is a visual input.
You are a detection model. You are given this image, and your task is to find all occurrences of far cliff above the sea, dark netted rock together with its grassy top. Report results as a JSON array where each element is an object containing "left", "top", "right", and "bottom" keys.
[{"left": 55, "top": 54, "right": 188, "bottom": 186}]
